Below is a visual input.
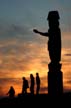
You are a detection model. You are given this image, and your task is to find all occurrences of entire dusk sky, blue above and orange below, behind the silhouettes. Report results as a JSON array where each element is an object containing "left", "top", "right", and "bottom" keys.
[{"left": 0, "top": 0, "right": 71, "bottom": 96}]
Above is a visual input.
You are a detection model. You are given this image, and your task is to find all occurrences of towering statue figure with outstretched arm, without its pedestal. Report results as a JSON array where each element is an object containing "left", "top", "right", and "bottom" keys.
[{"left": 33, "top": 11, "right": 61, "bottom": 64}]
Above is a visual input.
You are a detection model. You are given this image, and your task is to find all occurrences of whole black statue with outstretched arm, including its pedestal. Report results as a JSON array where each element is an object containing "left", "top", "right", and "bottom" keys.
[{"left": 33, "top": 11, "right": 63, "bottom": 95}]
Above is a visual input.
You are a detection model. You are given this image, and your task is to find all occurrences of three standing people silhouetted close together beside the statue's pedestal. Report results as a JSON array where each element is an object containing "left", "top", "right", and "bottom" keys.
[{"left": 22, "top": 73, "right": 40, "bottom": 94}]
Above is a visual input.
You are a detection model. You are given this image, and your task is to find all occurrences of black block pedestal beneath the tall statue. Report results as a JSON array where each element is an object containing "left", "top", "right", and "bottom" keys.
[{"left": 48, "top": 64, "right": 63, "bottom": 96}]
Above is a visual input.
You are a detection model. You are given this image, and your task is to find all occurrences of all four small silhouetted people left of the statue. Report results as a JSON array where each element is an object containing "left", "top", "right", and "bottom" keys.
[{"left": 7, "top": 73, "right": 40, "bottom": 98}]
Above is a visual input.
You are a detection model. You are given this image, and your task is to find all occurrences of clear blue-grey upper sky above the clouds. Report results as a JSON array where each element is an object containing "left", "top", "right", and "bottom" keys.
[{"left": 0, "top": 0, "right": 71, "bottom": 30}]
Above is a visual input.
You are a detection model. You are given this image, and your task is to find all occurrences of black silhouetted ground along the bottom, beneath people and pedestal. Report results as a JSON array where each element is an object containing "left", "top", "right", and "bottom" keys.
[{"left": 0, "top": 93, "right": 71, "bottom": 108}]
